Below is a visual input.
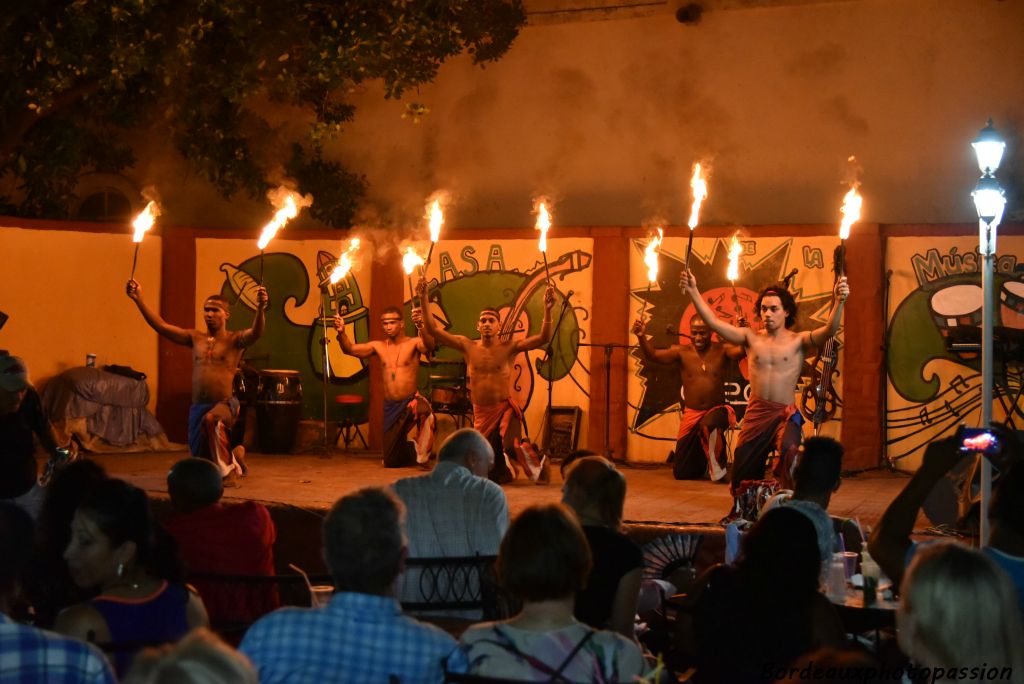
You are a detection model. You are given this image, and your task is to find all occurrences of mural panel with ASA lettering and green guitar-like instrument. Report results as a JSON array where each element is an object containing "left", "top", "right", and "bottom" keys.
[{"left": 415, "top": 239, "right": 593, "bottom": 447}]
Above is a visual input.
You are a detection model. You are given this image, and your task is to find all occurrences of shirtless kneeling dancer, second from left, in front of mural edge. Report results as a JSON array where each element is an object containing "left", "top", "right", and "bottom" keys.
[{"left": 334, "top": 306, "right": 434, "bottom": 468}]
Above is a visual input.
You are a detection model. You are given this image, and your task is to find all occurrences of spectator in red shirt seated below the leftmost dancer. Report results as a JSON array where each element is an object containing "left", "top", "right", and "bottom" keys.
[{"left": 165, "top": 458, "right": 281, "bottom": 625}]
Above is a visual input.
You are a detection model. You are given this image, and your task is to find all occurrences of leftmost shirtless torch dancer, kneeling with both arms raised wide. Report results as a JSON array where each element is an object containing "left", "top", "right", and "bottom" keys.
[{"left": 126, "top": 281, "right": 267, "bottom": 478}]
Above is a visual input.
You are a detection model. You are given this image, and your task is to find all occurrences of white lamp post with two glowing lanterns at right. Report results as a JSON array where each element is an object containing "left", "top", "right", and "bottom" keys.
[{"left": 971, "top": 119, "right": 1007, "bottom": 546}]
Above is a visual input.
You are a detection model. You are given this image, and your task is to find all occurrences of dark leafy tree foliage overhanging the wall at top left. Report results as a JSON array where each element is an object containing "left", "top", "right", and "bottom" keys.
[{"left": 0, "top": 0, "right": 524, "bottom": 226}]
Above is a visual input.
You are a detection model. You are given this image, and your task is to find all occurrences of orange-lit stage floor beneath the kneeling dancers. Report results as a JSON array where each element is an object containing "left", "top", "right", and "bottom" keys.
[{"left": 89, "top": 451, "right": 917, "bottom": 528}]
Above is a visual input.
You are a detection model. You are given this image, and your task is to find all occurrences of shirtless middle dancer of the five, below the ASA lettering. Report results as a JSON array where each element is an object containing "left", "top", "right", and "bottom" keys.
[{"left": 416, "top": 277, "right": 555, "bottom": 484}]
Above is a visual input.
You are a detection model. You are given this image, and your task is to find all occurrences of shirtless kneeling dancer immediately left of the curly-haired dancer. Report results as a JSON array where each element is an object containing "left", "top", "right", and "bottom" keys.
[{"left": 633, "top": 315, "right": 743, "bottom": 482}]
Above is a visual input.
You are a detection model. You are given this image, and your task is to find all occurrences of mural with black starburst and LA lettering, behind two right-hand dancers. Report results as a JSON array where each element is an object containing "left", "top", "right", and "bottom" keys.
[{"left": 627, "top": 235, "right": 843, "bottom": 463}]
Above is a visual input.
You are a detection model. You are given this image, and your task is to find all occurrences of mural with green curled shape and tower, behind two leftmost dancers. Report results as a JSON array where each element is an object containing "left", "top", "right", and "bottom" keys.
[{"left": 196, "top": 239, "right": 373, "bottom": 423}]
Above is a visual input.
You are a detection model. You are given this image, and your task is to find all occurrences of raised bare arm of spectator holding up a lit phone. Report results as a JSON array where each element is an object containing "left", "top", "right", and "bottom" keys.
[{"left": 867, "top": 437, "right": 964, "bottom": 587}]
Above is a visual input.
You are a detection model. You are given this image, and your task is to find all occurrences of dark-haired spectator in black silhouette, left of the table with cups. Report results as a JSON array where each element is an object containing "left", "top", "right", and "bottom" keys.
[{"left": 688, "top": 506, "right": 846, "bottom": 684}]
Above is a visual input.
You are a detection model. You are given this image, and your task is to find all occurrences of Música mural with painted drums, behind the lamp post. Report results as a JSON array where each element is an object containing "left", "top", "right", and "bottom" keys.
[{"left": 885, "top": 236, "right": 1024, "bottom": 469}]
